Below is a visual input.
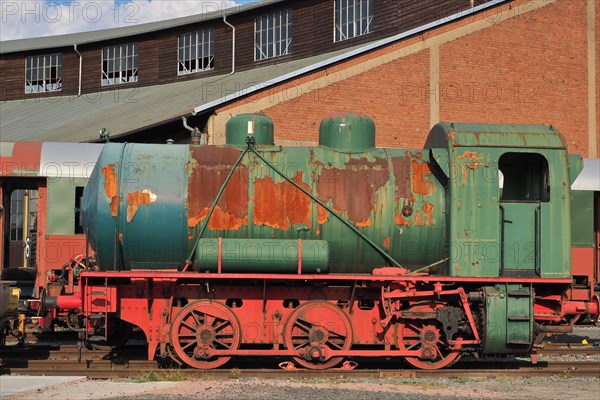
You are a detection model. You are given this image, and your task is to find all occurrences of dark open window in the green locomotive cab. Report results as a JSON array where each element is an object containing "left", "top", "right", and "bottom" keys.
[{"left": 498, "top": 153, "right": 550, "bottom": 202}]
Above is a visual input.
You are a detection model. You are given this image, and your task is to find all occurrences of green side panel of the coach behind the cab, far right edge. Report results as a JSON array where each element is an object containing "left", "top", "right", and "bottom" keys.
[{"left": 571, "top": 190, "right": 595, "bottom": 247}]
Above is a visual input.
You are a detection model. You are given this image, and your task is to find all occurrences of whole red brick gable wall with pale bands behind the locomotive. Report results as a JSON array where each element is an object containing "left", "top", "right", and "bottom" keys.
[{"left": 214, "top": 0, "right": 600, "bottom": 157}]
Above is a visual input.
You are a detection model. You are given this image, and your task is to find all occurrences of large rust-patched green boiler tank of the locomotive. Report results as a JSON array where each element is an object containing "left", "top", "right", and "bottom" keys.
[{"left": 86, "top": 144, "right": 445, "bottom": 272}]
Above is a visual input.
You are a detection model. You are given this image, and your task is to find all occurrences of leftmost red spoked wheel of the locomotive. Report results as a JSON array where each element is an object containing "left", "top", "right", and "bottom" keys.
[{"left": 171, "top": 300, "right": 241, "bottom": 369}]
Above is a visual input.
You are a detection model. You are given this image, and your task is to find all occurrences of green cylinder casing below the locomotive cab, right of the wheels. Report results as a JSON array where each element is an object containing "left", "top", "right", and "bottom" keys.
[{"left": 482, "top": 284, "right": 534, "bottom": 354}]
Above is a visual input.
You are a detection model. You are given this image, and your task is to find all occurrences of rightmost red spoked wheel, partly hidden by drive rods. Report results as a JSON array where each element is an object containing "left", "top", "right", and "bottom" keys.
[{"left": 396, "top": 303, "right": 460, "bottom": 370}]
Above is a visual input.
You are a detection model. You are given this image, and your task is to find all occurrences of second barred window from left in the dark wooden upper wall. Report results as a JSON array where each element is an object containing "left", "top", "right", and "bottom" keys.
[{"left": 102, "top": 43, "right": 138, "bottom": 86}]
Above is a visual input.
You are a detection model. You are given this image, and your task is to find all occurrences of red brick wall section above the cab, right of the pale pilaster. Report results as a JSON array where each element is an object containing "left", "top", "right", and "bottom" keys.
[{"left": 440, "top": 0, "right": 588, "bottom": 153}]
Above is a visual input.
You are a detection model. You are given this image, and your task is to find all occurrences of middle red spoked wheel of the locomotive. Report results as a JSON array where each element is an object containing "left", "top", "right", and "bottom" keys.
[{"left": 285, "top": 301, "right": 352, "bottom": 369}]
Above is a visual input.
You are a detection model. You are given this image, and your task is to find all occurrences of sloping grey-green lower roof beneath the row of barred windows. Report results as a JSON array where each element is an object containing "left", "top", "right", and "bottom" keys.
[{"left": 0, "top": 49, "right": 348, "bottom": 142}]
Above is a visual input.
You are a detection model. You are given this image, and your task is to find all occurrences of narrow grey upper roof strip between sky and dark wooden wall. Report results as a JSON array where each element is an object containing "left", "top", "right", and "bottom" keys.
[{"left": 0, "top": 0, "right": 286, "bottom": 54}]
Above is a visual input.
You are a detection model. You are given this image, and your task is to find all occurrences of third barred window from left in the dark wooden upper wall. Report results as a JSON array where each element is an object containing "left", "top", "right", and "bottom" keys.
[{"left": 177, "top": 29, "right": 215, "bottom": 75}]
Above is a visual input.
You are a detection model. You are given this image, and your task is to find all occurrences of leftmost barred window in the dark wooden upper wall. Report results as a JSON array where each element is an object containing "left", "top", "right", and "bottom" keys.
[{"left": 25, "top": 54, "right": 62, "bottom": 93}]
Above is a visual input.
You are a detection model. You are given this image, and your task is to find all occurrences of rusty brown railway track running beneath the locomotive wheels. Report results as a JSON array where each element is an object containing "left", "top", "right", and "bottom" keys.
[{"left": 0, "top": 340, "right": 600, "bottom": 379}]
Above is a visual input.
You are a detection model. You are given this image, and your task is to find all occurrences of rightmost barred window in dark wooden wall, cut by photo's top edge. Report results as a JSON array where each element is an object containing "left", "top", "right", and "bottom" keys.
[{"left": 334, "top": 0, "right": 373, "bottom": 42}]
